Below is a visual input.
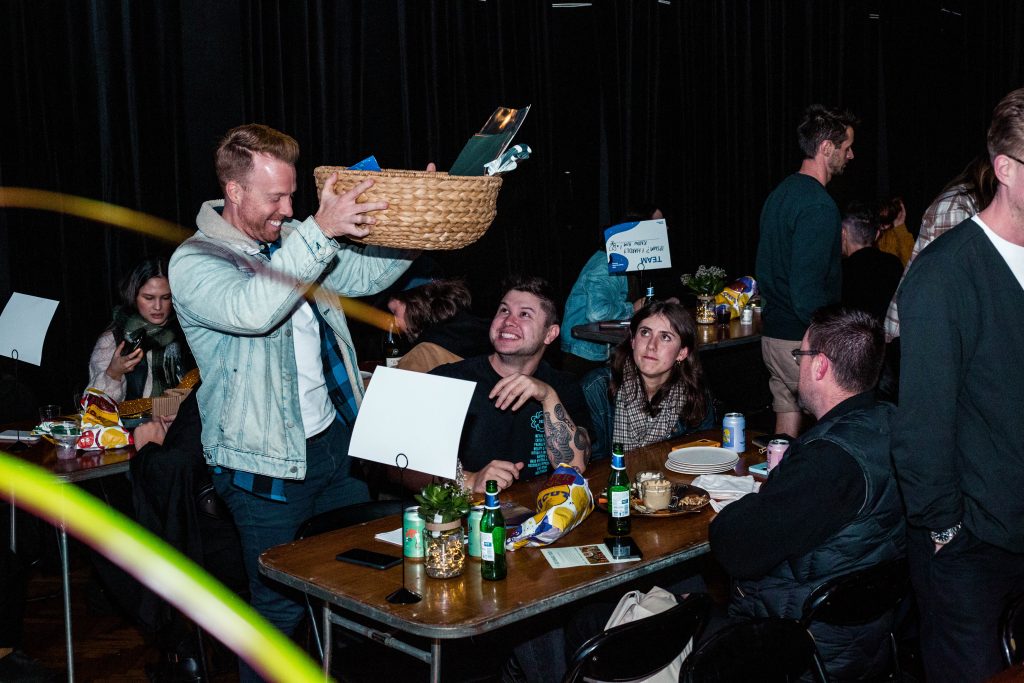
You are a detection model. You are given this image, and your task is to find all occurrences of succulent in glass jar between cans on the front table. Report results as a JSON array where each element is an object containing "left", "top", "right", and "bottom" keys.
[{"left": 415, "top": 481, "right": 469, "bottom": 579}]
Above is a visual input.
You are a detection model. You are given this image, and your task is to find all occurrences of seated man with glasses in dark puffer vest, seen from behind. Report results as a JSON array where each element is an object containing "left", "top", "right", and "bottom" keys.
[{"left": 711, "top": 307, "right": 905, "bottom": 680}]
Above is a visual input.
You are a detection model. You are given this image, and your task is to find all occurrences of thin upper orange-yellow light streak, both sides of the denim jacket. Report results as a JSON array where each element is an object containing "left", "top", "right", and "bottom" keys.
[{"left": 0, "top": 187, "right": 394, "bottom": 330}]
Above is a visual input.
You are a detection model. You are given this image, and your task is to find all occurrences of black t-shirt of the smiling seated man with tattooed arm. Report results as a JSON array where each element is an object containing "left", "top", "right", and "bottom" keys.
[{"left": 430, "top": 355, "right": 590, "bottom": 480}]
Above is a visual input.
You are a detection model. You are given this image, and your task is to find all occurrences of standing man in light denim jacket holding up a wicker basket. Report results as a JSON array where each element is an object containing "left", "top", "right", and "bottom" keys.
[{"left": 170, "top": 124, "right": 416, "bottom": 663}]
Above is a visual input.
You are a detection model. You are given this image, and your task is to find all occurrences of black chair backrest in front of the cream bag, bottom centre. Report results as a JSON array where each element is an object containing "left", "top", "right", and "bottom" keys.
[{"left": 562, "top": 593, "right": 711, "bottom": 683}]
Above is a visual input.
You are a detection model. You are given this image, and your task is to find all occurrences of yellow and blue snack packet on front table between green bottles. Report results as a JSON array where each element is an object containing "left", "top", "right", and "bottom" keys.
[{"left": 505, "top": 465, "right": 594, "bottom": 550}]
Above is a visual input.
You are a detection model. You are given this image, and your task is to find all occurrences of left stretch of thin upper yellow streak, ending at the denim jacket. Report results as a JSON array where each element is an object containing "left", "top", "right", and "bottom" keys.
[{"left": 0, "top": 187, "right": 191, "bottom": 244}]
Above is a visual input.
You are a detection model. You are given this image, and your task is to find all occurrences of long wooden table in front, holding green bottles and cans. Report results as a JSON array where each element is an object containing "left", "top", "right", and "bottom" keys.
[{"left": 260, "top": 431, "right": 763, "bottom": 681}]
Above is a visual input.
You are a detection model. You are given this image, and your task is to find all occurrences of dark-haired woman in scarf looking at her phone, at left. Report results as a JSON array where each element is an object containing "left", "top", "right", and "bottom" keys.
[{"left": 89, "top": 258, "right": 196, "bottom": 402}]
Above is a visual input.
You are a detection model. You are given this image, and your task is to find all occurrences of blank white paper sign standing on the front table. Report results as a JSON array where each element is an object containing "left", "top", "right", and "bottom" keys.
[{"left": 348, "top": 367, "right": 476, "bottom": 479}]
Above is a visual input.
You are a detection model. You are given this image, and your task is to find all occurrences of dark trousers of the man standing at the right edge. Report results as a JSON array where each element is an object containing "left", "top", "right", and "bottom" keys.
[{"left": 907, "top": 526, "right": 1024, "bottom": 683}]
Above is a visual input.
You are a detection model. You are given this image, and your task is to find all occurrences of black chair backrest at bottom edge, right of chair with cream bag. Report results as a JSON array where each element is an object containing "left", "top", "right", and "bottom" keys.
[{"left": 679, "top": 617, "right": 828, "bottom": 683}]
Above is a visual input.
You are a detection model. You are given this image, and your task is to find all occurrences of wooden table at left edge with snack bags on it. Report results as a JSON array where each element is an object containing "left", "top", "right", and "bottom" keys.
[{"left": 0, "top": 427, "right": 135, "bottom": 683}]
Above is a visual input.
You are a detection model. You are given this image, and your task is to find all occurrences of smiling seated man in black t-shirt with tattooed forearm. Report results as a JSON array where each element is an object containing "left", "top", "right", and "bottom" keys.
[{"left": 431, "top": 278, "right": 590, "bottom": 493}]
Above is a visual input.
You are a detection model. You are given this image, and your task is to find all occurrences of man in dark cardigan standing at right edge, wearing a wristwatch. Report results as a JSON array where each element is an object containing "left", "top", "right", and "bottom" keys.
[{"left": 893, "top": 88, "right": 1024, "bottom": 682}]
